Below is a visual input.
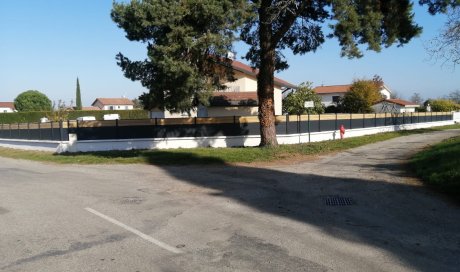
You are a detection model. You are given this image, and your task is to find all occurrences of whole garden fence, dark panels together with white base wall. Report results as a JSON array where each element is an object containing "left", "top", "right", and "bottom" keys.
[{"left": 0, "top": 112, "right": 454, "bottom": 152}]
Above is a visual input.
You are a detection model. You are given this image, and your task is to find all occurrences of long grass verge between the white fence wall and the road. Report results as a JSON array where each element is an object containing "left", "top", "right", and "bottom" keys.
[{"left": 0, "top": 125, "right": 460, "bottom": 165}]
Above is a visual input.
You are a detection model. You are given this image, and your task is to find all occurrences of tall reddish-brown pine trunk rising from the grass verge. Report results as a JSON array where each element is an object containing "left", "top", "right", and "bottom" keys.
[{"left": 257, "top": 3, "right": 278, "bottom": 147}]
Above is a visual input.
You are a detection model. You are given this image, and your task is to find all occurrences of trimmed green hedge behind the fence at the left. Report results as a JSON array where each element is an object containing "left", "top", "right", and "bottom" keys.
[{"left": 0, "top": 110, "right": 149, "bottom": 124}]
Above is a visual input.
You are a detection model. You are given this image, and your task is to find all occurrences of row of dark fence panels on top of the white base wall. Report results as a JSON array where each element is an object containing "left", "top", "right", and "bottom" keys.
[{"left": 0, "top": 113, "right": 453, "bottom": 141}]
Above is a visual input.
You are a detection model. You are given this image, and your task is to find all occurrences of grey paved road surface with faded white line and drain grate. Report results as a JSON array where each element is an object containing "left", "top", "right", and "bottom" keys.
[{"left": 0, "top": 130, "right": 460, "bottom": 272}]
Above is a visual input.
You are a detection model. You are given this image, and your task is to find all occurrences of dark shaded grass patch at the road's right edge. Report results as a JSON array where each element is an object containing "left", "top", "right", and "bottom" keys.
[{"left": 410, "top": 137, "right": 460, "bottom": 202}]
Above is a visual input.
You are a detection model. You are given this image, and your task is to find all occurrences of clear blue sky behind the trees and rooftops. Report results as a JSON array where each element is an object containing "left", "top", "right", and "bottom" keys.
[{"left": 0, "top": 0, "right": 460, "bottom": 106}]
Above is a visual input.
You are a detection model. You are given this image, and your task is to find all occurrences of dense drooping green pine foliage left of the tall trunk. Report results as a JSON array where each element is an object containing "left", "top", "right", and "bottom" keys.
[{"left": 111, "top": 0, "right": 245, "bottom": 112}]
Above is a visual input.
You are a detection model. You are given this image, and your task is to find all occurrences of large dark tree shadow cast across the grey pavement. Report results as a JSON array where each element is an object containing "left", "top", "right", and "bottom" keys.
[{"left": 154, "top": 155, "right": 460, "bottom": 271}]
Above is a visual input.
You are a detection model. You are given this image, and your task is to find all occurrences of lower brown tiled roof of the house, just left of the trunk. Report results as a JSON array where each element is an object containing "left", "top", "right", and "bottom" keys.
[{"left": 210, "top": 92, "right": 258, "bottom": 106}]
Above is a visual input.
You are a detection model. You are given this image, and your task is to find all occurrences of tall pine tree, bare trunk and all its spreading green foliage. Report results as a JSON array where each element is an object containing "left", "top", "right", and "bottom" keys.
[{"left": 111, "top": 0, "right": 457, "bottom": 146}]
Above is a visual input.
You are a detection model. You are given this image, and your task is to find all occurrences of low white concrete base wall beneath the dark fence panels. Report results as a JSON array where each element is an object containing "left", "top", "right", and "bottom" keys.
[{"left": 0, "top": 119, "right": 452, "bottom": 153}]
